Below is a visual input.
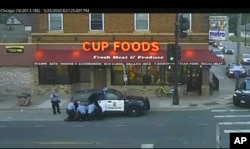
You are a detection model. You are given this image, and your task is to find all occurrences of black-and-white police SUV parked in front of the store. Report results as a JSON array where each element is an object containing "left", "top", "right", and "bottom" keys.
[{"left": 71, "top": 87, "right": 150, "bottom": 117}]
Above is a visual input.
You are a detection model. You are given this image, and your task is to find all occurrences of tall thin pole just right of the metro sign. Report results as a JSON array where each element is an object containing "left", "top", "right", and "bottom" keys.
[{"left": 235, "top": 14, "right": 241, "bottom": 89}]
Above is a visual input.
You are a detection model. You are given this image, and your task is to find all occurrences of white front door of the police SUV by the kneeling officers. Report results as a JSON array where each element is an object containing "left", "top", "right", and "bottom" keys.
[{"left": 104, "top": 92, "right": 124, "bottom": 112}]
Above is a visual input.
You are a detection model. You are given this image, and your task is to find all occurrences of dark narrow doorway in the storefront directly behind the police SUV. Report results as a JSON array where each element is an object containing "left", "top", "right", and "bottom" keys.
[{"left": 94, "top": 66, "right": 107, "bottom": 88}]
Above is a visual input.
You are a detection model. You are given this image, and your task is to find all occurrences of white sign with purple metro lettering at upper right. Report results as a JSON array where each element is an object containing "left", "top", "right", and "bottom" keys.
[{"left": 208, "top": 16, "right": 228, "bottom": 40}]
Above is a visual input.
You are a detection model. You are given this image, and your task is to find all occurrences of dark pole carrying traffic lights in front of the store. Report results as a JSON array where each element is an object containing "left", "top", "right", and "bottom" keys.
[{"left": 173, "top": 13, "right": 180, "bottom": 105}]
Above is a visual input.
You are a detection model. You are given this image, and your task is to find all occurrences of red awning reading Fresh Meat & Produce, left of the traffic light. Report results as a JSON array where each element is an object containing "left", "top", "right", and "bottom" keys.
[{"left": 34, "top": 49, "right": 167, "bottom": 65}]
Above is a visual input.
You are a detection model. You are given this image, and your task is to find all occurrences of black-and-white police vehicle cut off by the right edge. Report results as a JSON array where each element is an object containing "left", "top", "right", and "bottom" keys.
[{"left": 233, "top": 77, "right": 250, "bottom": 107}]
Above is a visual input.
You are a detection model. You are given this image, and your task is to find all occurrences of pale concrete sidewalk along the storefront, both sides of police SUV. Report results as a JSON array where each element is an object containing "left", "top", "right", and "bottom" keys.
[{"left": 0, "top": 91, "right": 232, "bottom": 111}]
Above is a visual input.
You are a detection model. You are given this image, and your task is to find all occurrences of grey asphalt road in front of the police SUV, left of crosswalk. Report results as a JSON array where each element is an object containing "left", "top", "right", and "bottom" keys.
[{"left": 0, "top": 110, "right": 220, "bottom": 148}]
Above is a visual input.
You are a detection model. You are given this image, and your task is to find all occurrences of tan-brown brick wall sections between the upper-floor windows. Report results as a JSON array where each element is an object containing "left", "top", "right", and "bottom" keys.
[{"left": 33, "top": 13, "right": 208, "bottom": 33}]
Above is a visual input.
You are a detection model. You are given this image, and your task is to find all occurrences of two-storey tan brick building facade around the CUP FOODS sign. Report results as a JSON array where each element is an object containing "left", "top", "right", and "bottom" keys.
[{"left": 0, "top": 13, "right": 222, "bottom": 96}]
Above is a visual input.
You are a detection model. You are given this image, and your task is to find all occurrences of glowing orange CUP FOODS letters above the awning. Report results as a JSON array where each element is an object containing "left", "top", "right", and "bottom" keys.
[{"left": 82, "top": 41, "right": 160, "bottom": 52}]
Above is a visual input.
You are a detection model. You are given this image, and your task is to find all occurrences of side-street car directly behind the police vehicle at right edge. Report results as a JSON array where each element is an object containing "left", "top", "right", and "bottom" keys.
[{"left": 226, "top": 63, "right": 247, "bottom": 78}]
